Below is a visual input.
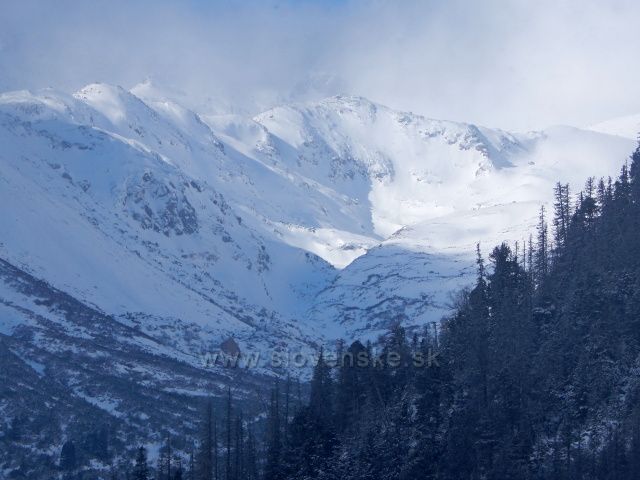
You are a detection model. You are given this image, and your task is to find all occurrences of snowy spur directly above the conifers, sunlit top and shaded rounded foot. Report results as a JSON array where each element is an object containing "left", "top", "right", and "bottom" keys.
[{"left": 310, "top": 127, "right": 633, "bottom": 339}]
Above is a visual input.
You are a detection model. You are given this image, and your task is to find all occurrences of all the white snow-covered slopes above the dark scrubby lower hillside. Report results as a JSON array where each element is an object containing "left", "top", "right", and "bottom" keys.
[{"left": 0, "top": 82, "right": 631, "bottom": 344}]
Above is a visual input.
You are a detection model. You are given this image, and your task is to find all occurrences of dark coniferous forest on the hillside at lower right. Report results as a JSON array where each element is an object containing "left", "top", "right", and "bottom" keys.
[{"left": 60, "top": 142, "right": 640, "bottom": 480}]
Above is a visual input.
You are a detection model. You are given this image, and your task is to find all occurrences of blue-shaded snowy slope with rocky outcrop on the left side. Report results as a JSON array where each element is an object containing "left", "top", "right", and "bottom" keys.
[{"left": 0, "top": 85, "right": 331, "bottom": 368}]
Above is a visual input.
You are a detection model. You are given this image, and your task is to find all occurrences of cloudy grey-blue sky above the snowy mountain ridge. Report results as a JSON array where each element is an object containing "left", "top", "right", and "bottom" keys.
[{"left": 0, "top": 0, "right": 640, "bottom": 130}]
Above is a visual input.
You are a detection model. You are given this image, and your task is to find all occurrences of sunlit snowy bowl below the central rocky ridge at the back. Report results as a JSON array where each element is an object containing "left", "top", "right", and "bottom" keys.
[{"left": 256, "top": 97, "right": 526, "bottom": 238}]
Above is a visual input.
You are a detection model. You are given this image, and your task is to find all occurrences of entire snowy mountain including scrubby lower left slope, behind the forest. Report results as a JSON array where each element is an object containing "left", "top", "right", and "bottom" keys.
[{"left": 0, "top": 80, "right": 634, "bottom": 474}]
